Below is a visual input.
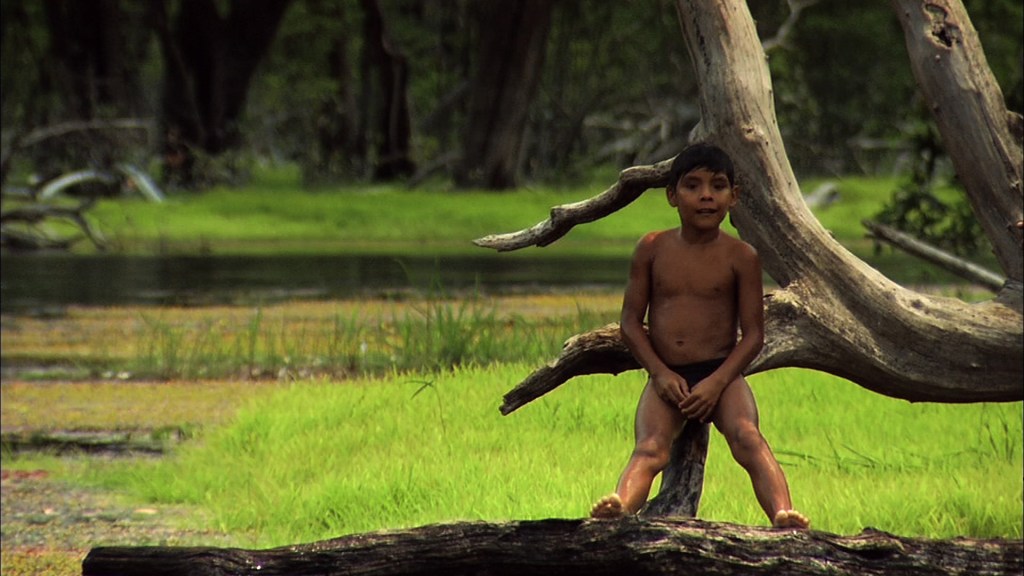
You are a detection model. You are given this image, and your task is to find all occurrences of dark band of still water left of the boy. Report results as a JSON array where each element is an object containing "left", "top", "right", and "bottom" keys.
[{"left": 0, "top": 253, "right": 629, "bottom": 314}]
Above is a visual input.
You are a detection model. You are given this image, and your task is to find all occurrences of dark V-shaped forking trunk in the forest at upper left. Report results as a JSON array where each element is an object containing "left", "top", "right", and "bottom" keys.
[{"left": 153, "top": 0, "right": 291, "bottom": 183}]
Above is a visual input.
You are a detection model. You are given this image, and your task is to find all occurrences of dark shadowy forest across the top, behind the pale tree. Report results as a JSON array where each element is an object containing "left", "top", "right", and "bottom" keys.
[{"left": 0, "top": 0, "right": 1024, "bottom": 202}]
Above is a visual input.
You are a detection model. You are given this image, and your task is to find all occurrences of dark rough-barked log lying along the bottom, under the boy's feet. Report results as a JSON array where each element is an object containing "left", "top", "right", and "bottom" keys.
[{"left": 82, "top": 518, "right": 1024, "bottom": 576}]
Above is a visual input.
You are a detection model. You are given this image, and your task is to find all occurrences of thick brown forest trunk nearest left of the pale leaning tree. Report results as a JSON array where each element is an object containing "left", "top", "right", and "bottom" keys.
[{"left": 456, "top": 0, "right": 551, "bottom": 190}]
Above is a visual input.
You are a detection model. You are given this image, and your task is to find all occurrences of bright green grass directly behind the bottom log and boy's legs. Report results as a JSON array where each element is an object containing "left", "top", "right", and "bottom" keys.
[{"left": 70, "top": 364, "right": 1024, "bottom": 546}]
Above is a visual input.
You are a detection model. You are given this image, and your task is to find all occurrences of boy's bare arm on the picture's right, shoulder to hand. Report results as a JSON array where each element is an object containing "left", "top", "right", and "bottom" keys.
[{"left": 679, "top": 239, "right": 765, "bottom": 421}]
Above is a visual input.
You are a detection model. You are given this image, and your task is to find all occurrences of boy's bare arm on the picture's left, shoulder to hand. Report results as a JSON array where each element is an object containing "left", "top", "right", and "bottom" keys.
[{"left": 620, "top": 233, "right": 690, "bottom": 406}]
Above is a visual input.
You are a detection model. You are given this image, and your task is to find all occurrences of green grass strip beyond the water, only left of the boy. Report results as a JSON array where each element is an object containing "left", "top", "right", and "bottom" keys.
[{"left": 82, "top": 163, "right": 673, "bottom": 254}]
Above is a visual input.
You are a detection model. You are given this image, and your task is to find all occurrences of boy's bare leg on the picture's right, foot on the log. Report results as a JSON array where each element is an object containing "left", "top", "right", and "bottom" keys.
[{"left": 713, "top": 376, "right": 810, "bottom": 528}]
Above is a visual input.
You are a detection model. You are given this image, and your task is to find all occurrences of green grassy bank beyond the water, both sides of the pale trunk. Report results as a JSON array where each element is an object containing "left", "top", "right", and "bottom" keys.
[{"left": 68, "top": 162, "right": 995, "bottom": 284}]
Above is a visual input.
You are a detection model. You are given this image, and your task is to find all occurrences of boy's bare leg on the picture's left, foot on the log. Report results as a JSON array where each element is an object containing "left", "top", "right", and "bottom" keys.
[{"left": 591, "top": 381, "right": 685, "bottom": 518}]
